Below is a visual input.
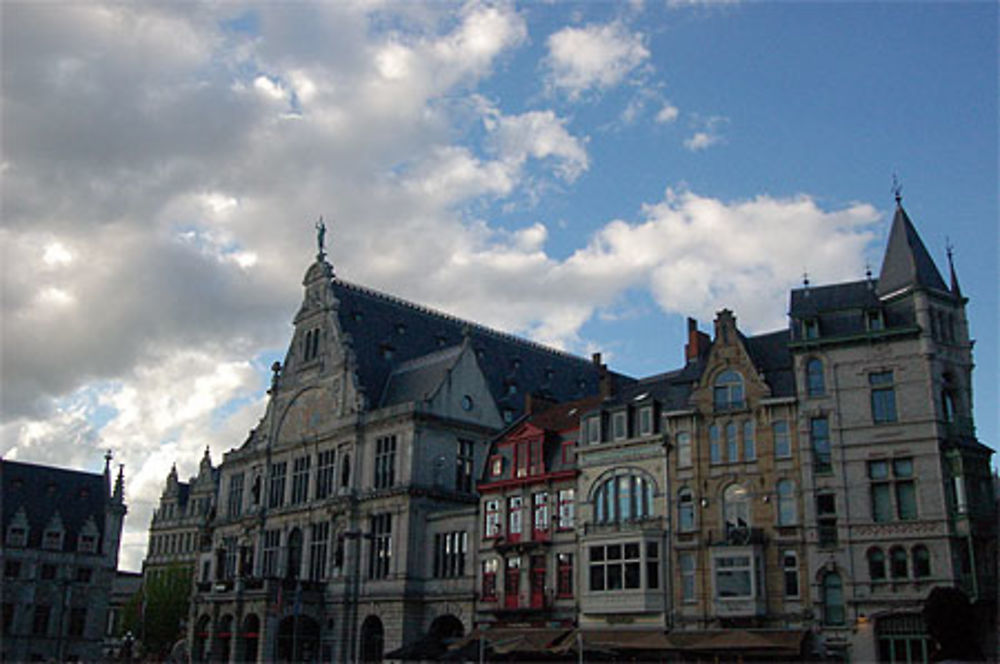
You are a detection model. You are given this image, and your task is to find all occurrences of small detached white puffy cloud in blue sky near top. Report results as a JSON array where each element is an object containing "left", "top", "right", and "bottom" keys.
[{"left": 546, "top": 21, "right": 649, "bottom": 99}]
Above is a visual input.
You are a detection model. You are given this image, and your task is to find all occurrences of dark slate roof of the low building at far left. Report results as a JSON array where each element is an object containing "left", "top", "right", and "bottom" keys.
[{"left": 0, "top": 460, "right": 109, "bottom": 551}]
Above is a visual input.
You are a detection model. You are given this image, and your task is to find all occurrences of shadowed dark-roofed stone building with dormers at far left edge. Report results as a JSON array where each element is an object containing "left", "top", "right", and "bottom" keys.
[{"left": 0, "top": 454, "right": 126, "bottom": 662}]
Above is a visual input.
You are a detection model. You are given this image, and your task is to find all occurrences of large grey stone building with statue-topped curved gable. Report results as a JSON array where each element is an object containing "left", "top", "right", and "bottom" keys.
[{"left": 183, "top": 245, "right": 614, "bottom": 661}]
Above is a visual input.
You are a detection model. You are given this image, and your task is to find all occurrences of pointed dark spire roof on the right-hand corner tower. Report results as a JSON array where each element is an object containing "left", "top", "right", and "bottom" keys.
[{"left": 876, "top": 197, "right": 948, "bottom": 297}]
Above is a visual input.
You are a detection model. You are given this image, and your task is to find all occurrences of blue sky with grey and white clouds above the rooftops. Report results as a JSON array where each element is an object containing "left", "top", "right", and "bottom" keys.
[{"left": 0, "top": 0, "right": 1000, "bottom": 570}]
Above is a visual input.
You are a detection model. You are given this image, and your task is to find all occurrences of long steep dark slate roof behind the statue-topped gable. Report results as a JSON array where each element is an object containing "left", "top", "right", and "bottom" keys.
[{"left": 331, "top": 278, "right": 631, "bottom": 417}]
